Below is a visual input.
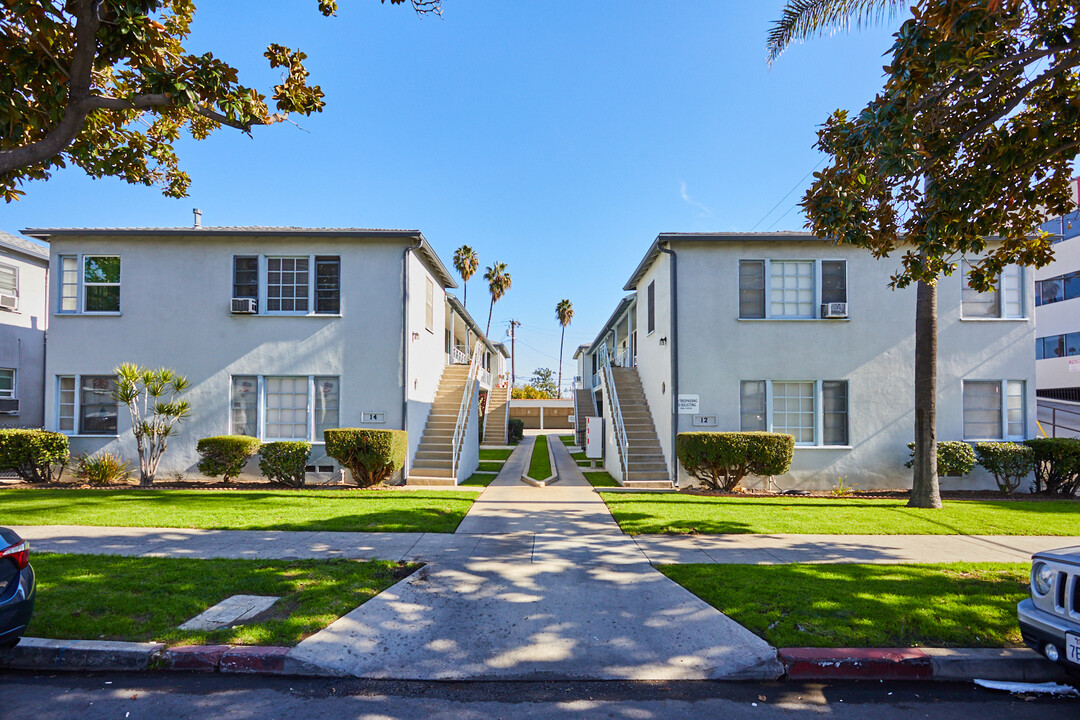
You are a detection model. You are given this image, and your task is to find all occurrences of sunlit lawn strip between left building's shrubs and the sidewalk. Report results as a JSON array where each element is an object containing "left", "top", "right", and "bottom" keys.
[{"left": 0, "top": 488, "right": 477, "bottom": 532}]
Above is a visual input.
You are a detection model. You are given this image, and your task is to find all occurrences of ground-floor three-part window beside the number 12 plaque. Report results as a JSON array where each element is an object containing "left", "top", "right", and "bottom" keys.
[{"left": 739, "top": 380, "right": 849, "bottom": 447}]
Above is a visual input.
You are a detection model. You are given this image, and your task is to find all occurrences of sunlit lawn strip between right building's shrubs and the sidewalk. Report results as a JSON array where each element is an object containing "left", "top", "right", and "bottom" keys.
[{"left": 603, "top": 493, "right": 1080, "bottom": 535}]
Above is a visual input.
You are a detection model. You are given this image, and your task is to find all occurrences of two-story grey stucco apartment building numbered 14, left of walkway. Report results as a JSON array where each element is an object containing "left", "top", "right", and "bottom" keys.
[{"left": 25, "top": 225, "right": 505, "bottom": 484}]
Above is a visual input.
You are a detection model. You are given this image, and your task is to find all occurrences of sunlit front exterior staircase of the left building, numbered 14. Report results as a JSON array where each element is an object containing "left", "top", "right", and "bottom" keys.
[{"left": 405, "top": 365, "right": 469, "bottom": 485}]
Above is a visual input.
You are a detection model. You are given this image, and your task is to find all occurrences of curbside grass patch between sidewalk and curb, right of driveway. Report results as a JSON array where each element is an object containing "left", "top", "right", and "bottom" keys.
[{"left": 658, "top": 562, "right": 1029, "bottom": 648}]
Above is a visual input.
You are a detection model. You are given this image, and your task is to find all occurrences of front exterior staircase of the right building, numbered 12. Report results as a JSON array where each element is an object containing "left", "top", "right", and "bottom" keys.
[{"left": 611, "top": 367, "right": 672, "bottom": 488}]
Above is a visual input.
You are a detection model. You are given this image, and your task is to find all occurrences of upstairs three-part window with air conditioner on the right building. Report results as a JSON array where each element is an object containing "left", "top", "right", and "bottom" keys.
[{"left": 739, "top": 259, "right": 848, "bottom": 320}]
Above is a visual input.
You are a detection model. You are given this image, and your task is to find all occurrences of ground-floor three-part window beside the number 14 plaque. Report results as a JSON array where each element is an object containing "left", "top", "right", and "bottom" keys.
[{"left": 230, "top": 375, "right": 341, "bottom": 443}]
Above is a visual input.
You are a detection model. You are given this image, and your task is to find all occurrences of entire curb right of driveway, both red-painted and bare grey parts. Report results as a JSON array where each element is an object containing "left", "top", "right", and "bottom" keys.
[{"left": 778, "top": 648, "right": 1067, "bottom": 682}]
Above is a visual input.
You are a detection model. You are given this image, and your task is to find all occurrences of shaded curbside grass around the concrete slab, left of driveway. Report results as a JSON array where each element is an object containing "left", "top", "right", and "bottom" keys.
[{"left": 28, "top": 553, "right": 418, "bottom": 646}]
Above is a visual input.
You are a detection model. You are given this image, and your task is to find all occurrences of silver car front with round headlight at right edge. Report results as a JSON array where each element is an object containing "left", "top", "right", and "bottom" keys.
[{"left": 1016, "top": 545, "right": 1080, "bottom": 677}]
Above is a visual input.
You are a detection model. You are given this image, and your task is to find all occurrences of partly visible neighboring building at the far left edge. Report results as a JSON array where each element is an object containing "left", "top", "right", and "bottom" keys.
[{"left": 0, "top": 232, "right": 49, "bottom": 427}]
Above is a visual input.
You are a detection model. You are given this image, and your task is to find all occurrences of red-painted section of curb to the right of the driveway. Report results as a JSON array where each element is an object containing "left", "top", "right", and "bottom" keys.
[{"left": 778, "top": 648, "right": 934, "bottom": 680}]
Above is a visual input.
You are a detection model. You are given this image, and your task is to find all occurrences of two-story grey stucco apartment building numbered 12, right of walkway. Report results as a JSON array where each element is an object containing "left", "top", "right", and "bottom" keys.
[{"left": 576, "top": 232, "right": 1036, "bottom": 489}]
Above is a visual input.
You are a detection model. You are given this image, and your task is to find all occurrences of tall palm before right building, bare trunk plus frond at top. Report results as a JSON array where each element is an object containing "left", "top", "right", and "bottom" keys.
[{"left": 766, "top": 0, "right": 942, "bottom": 507}]
